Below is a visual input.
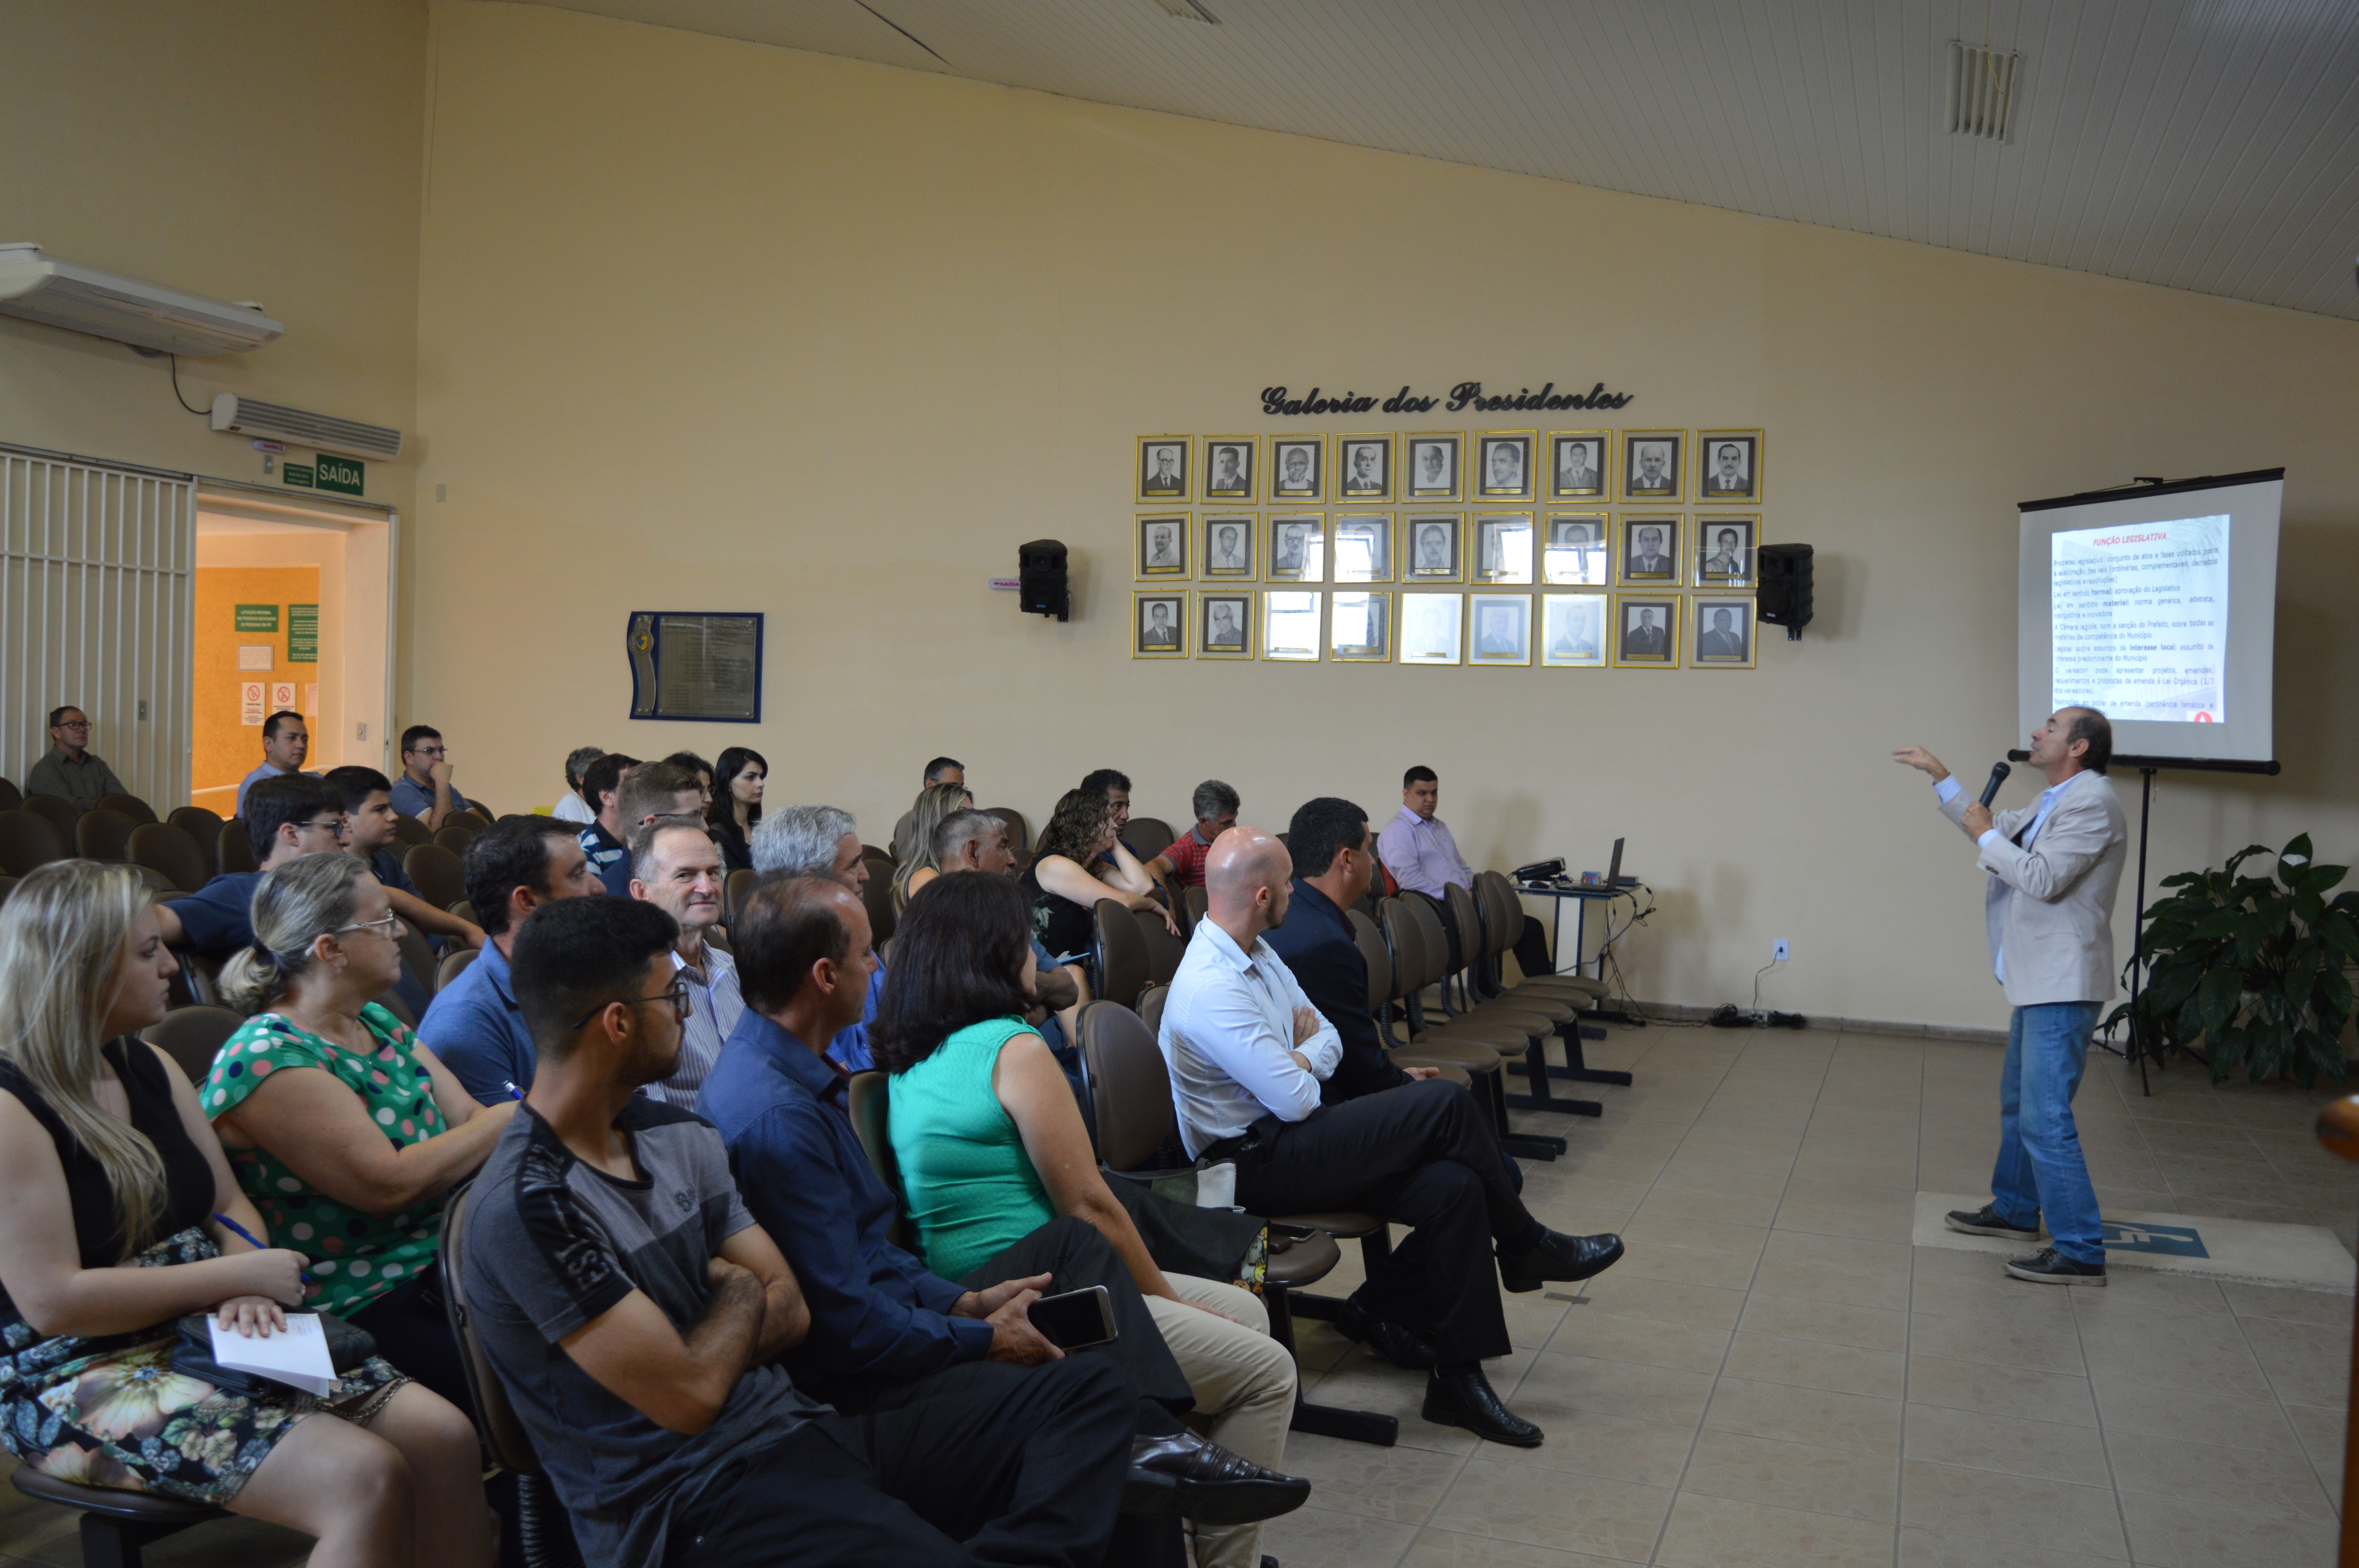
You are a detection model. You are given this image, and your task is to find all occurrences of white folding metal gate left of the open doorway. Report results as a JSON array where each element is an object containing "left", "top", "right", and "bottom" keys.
[{"left": 0, "top": 448, "right": 196, "bottom": 816}]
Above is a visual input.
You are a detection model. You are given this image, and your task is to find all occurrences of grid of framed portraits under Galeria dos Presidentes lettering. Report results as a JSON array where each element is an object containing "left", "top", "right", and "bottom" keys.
[{"left": 1130, "top": 429, "right": 1765, "bottom": 670}]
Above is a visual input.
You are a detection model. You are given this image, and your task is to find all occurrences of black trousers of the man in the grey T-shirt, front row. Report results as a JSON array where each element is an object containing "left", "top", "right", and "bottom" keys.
[{"left": 663, "top": 1356, "right": 1137, "bottom": 1568}]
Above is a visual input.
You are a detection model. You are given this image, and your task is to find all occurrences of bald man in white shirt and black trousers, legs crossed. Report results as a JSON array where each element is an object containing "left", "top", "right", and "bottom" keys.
[{"left": 1161, "top": 828, "right": 1621, "bottom": 1448}]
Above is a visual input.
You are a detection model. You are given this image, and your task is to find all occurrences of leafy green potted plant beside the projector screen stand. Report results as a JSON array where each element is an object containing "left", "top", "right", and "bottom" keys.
[{"left": 2104, "top": 832, "right": 2359, "bottom": 1087}]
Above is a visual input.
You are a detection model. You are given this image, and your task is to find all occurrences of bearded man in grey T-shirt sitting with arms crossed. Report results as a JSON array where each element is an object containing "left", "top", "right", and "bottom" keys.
[{"left": 462, "top": 898, "right": 1137, "bottom": 1568}]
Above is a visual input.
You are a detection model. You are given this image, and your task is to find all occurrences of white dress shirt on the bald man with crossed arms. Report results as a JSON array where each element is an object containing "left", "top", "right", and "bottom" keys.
[{"left": 1158, "top": 920, "right": 1342, "bottom": 1158}]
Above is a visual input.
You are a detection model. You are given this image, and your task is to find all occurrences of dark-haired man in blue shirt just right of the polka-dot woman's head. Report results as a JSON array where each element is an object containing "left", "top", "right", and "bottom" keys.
[{"left": 418, "top": 816, "right": 606, "bottom": 1106}]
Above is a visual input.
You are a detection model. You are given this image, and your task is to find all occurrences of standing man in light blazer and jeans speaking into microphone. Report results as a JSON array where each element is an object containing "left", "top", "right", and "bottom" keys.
[{"left": 1892, "top": 708, "right": 2130, "bottom": 1285}]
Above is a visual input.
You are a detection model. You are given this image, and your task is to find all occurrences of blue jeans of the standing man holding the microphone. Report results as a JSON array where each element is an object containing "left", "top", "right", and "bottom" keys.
[{"left": 1991, "top": 1002, "right": 2104, "bottom": 1264}]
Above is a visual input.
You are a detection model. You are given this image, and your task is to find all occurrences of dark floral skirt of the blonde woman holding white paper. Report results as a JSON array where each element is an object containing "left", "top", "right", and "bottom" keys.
[{"left": 0, "top": 1229, "right": 406, "bottom": 1507}]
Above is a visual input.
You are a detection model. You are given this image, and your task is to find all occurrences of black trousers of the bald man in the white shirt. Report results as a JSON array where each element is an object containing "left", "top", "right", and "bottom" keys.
[{"left": 1219, "top": 1078, "right": 1531, "bottom": 1361}]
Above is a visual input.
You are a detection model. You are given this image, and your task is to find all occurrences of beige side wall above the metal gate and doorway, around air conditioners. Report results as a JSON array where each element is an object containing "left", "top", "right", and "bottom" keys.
[{"left": 0, "top": 0, "right": 427, "bottom": 509}]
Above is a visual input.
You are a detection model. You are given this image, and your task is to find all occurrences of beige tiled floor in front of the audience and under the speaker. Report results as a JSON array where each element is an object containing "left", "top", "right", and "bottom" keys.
[{"left": 0, "top": 1028, "right": 2359, "bottom": 1568}]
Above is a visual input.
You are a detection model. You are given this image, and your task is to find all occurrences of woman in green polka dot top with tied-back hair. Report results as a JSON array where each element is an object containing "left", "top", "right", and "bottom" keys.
[{"left": 198, "top": 853, "right": 517, "bottom": 1408}]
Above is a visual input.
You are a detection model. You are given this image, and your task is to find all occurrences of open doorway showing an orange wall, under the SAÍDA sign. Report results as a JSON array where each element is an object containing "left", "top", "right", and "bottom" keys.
[{"left": 189, "top": 486, "right": 396, "bottom": 816}]
